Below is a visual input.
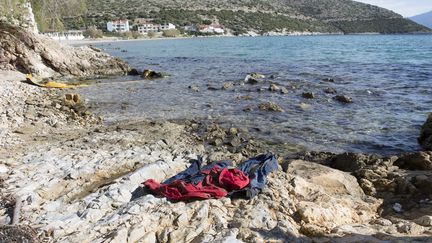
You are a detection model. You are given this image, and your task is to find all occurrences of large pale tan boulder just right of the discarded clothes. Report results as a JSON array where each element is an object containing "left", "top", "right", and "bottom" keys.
[{"left": 287, "top": 160, "right": 380, "bottom": 230}]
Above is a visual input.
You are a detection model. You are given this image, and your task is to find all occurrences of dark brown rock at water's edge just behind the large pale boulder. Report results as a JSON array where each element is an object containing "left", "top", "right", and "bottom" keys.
[{"left": 330, "top": 153, "right": 368, "bottom": 172}]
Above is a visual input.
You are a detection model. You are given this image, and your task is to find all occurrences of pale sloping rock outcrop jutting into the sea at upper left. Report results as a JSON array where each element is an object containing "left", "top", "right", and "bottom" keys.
[{"left": 0, "top": 22, "right": 129, "bottom": 77}]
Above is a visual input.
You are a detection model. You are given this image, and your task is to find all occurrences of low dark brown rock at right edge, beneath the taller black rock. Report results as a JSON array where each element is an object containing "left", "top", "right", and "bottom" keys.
[{"left": 394, "top": 152, "right": 432, "bottom": 170}]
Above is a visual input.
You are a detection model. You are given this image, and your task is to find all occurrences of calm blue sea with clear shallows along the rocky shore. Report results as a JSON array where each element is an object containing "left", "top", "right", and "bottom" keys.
[{"left": 79, "top": 35, "right": 432, "bottom": 155}]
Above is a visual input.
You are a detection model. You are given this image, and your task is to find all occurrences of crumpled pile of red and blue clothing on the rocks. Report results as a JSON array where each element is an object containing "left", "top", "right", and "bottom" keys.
[{"left": 143, "top": 154, "right": 278, "bottom": 201}]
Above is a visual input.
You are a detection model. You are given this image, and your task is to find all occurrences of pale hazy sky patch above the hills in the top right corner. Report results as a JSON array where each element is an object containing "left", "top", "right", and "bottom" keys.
[{"left": 355, "top": 0, "right": 432, "bottom": 17}]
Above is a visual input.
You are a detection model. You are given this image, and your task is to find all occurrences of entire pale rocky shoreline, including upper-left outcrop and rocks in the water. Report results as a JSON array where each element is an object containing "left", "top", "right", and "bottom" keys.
[{"left": 0, "top": 22, "right": 432, "bottom": 242}]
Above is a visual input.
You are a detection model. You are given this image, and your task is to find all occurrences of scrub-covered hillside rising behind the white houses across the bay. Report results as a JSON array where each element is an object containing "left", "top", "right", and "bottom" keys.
[{"left": 66, "top": 0, "right": 428, "bottom": 34}]
